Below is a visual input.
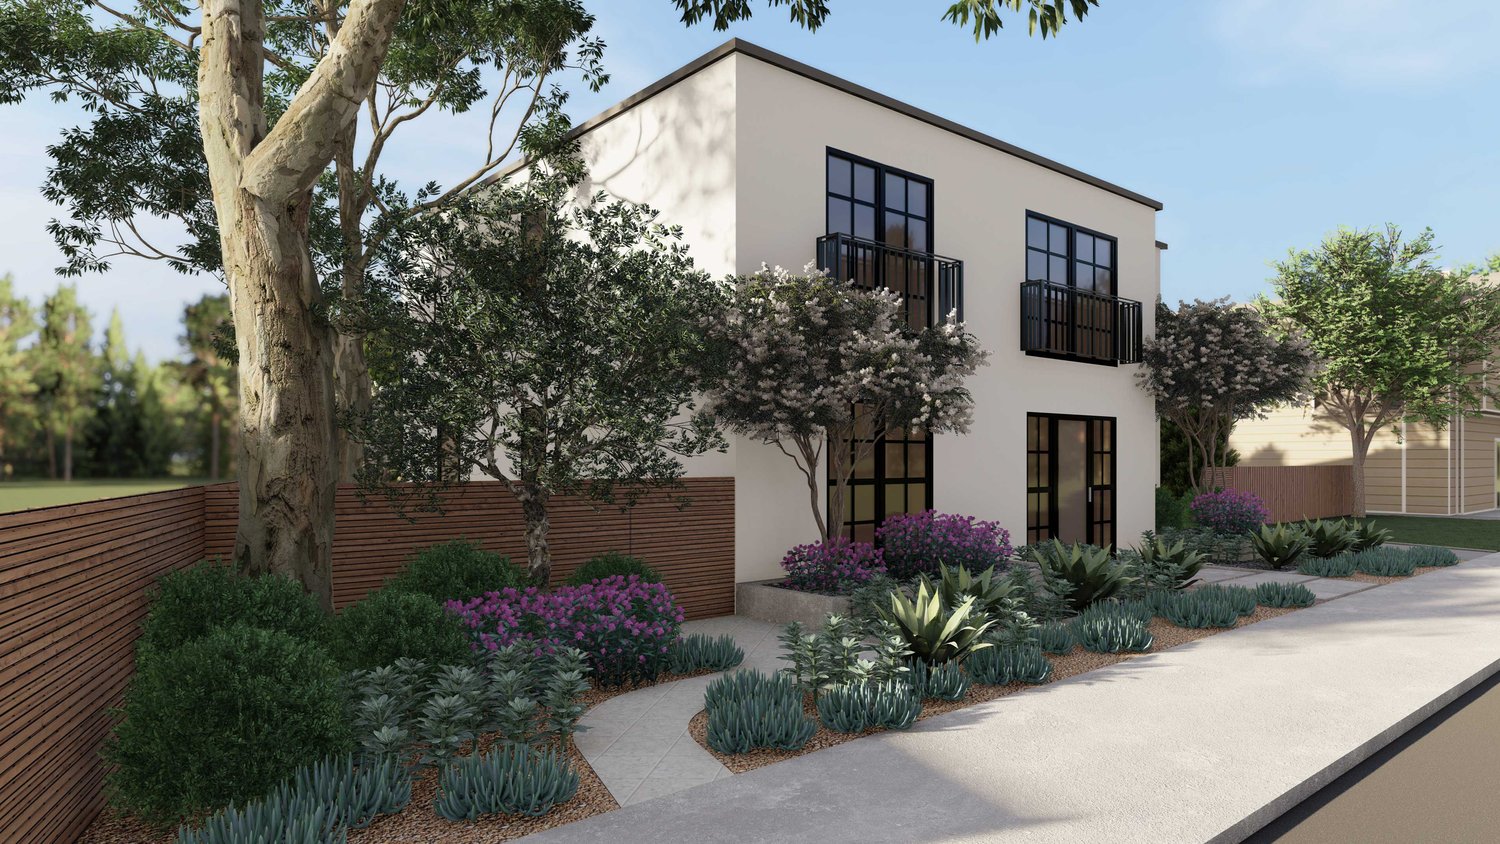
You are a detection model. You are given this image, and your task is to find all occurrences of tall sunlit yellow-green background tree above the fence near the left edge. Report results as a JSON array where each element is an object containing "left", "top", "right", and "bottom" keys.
[{"left": 36, "top": 285, "right": 99, "bottom": 481}]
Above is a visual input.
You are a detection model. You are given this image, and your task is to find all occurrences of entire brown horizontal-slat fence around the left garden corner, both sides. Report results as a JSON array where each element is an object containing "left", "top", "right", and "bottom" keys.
[{"left": 0, "top": 478, "right": 735, "bottom": 841}]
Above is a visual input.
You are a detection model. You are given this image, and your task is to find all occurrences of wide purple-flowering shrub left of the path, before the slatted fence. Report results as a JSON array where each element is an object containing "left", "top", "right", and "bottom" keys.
[{"left": 447, "top": 574, "right": 683, "bottom": 685}]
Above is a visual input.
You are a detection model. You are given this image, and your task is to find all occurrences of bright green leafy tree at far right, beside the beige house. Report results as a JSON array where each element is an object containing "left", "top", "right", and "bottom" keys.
[{"left": 1266, "top": 225, "right": 1500, "bottom": 516}]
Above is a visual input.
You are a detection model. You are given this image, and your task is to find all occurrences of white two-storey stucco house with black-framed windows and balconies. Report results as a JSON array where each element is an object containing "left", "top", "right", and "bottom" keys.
[{"left": 522, "top": 40, "right": 1166, "bottom": 580}]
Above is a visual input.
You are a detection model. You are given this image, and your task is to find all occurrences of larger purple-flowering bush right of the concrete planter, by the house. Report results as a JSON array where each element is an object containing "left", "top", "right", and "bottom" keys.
[{"left": 875, "top": 510, "right": 1013, "bottom": 580}]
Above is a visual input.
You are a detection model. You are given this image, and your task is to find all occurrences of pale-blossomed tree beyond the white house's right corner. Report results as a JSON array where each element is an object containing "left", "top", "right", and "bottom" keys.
[{"left": 1137, "top": 298, "right": 1314, "bottom": 492}]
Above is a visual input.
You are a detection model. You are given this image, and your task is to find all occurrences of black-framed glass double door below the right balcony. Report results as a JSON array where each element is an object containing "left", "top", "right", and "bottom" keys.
[{"left": 1026, "top": 414, "right": 1115, "bottom": 546}]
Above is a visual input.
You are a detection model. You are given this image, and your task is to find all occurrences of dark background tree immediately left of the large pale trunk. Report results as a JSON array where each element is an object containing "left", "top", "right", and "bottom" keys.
[{"left": 182, "top": 294, "right": 239, "bottom": 481}]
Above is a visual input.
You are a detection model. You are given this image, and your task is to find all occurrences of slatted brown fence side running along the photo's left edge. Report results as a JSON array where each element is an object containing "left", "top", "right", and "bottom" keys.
[{"left": 0, "top": 487, "right": 204, "bottom": 841}]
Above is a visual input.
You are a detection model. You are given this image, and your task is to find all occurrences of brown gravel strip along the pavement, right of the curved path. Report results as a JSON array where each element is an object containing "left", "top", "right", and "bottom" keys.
[{"left": 687, "top": 607, "right": 1295, "bottom": 774}]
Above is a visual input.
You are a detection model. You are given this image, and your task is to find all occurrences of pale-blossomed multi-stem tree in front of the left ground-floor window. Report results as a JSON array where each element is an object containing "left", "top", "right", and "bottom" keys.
[{"left": 707, "top": 264, "right": 989, "bottom": 540}]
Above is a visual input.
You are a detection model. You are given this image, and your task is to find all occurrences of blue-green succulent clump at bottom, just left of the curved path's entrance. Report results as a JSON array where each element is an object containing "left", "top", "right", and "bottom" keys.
[{"left": 432, "top": 745, "right": 578, "bottom": 820}]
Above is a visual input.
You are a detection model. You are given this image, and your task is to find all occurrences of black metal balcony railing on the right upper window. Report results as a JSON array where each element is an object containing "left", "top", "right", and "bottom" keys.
[{"left": 1022, "top": 282, "right": 1142, "bottom": 363}]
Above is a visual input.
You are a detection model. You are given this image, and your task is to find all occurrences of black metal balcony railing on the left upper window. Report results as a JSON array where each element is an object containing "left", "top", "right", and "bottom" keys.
[{"left": 818, "top": 234, "right": 963, "bottom": 327}]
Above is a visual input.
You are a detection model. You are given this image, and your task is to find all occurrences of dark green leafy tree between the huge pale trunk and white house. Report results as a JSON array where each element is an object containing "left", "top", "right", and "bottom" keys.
[{"left": 354, "top": 168, "right": 725, "bottom": 583}]
